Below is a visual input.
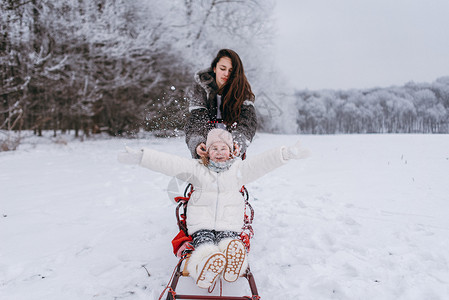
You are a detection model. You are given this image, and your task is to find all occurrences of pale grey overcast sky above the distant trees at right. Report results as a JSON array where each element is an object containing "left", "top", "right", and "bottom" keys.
[{"left": 275, "top": 0, "right": 449, "bottom": 90}]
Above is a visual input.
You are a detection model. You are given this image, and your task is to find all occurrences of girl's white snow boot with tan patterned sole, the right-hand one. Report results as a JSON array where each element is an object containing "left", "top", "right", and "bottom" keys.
[{"left": 218, "top": 239, "right": 248, "bottom": 282}]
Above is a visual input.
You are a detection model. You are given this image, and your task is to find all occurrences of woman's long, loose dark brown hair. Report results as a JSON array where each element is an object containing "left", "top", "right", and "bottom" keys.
[{"left": 211, "top": 49, "right": 255, "bottom": 126}]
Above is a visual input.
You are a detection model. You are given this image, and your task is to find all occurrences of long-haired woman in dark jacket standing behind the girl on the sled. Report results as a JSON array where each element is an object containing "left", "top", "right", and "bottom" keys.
[{"left": 184, "top": 49, "right": 257, "bottom": 158}]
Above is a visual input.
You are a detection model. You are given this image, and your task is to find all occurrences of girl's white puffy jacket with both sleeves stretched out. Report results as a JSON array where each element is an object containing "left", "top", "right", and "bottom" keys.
[{"left": 140, "top": 147, "right": 286, "bottom": 234}]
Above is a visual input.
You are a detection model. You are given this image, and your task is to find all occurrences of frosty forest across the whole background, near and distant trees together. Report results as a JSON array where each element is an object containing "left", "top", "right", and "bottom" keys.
[{"left": 0, "top": 0, "right": 449, "bottom": 150}]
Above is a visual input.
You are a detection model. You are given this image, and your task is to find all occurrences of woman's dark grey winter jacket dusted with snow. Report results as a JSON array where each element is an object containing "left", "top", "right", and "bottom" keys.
[{"left": 184, "top": 68, "right": 257, "bottom": 158}]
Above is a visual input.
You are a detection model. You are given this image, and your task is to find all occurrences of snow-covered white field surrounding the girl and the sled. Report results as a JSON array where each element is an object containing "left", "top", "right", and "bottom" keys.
[{"left": 0, "top": 134, "right": 449, "bottom": 300}]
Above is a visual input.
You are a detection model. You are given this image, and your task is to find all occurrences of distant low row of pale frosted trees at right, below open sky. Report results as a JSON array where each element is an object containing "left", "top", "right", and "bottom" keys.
[{"left": 294, "top": 77, "right": 449, "bottom": 134}]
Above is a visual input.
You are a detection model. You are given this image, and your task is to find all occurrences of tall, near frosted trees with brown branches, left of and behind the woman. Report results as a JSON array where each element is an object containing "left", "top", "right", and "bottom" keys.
[{"left": 0, "top": 0, "right": 272, "bottom": 150}]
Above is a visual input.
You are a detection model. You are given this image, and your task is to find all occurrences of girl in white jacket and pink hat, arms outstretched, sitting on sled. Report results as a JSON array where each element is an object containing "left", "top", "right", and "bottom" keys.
[{"left": 118, "top": 129, "right": 308, "bottom": 288}]
